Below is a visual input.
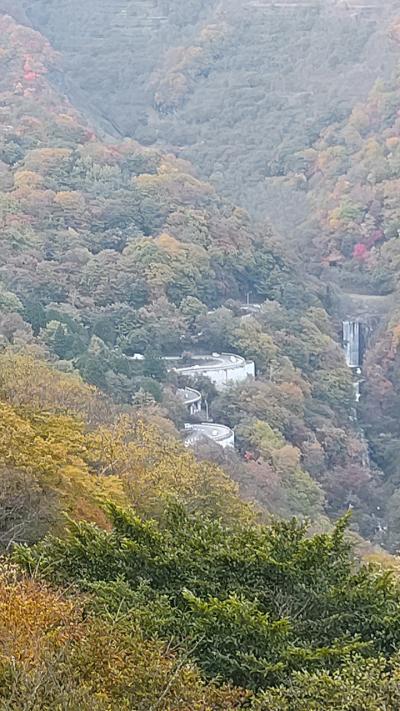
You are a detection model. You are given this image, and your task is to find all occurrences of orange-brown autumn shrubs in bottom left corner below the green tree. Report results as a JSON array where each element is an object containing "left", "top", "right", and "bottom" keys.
[{"left": 0, "top": 567, "right": 244, "bottom": 711}]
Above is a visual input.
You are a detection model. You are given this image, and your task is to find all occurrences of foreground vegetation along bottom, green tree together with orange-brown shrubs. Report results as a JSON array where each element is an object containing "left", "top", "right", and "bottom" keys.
[{"left": 0, "top": 504, "right": 399, "bottom": 711}]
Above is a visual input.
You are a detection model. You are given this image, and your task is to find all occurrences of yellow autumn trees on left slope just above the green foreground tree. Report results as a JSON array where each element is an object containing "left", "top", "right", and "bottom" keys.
[{"left": 0, "top": 352, "right": 255, "bottom": 551}]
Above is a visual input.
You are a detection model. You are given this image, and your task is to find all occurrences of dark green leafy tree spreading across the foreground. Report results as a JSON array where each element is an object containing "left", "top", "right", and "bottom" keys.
[{"left": 14, "top": 504, "right": 400, "bottom": 693}]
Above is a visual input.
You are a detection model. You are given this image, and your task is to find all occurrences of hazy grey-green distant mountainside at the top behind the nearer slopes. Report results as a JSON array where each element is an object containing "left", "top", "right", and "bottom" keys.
[{"left": 14, "top": 0, "right": 396, "bottom": 229}]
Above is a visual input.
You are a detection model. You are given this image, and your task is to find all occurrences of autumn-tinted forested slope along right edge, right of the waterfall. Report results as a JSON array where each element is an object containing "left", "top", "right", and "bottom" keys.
[{"left": 274, "top": 20, "right": 400, "bottom": 546}]
